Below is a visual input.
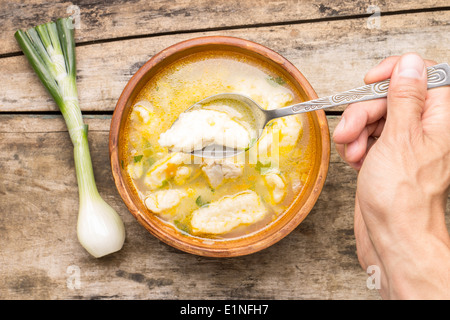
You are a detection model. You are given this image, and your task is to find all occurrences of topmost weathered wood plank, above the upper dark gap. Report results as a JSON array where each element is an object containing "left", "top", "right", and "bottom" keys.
[{"left": 0, "top": 0, "right": 448, "bottom": 54}]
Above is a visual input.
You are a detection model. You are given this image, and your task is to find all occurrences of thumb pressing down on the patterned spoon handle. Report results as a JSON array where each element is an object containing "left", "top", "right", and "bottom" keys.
[{"left": 385, "top": 53, "right": 427, "bottom": 134}]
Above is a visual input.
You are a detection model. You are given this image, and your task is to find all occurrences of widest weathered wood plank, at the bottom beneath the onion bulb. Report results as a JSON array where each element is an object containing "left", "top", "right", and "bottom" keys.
[{"left": 0, "top": 115, "right": 450, "bottom": 299}]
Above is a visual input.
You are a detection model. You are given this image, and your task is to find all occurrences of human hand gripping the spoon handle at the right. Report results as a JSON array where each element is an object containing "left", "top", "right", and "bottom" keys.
[{"left": 333, "top": 54, "right": 450, "bottom": 298}]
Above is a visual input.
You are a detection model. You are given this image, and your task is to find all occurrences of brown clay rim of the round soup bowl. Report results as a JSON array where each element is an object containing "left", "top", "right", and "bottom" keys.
[{"left": 109, "top": 36, "right": 330, "bottom": 257}]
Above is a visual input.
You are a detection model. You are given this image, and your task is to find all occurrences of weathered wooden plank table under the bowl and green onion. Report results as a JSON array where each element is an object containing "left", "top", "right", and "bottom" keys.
[{"left": 0, "top": 0, "right": 450, "bottom": 299}]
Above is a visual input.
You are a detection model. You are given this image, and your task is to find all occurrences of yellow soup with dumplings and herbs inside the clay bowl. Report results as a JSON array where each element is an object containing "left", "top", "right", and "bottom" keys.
[{"left": 121, "top": 51, "right": 315, "bottom": 239}]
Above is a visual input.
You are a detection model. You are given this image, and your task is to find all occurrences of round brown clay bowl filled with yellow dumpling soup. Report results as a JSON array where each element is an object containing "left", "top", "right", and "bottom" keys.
[{"left": 110, "top": 37, "right": 330, "bottom": 257}]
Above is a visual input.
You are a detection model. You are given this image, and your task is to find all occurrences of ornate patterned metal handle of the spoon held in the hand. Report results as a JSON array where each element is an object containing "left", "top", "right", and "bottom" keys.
[{"left": 270, "top": 63, "right": 450, "bottom": 119}]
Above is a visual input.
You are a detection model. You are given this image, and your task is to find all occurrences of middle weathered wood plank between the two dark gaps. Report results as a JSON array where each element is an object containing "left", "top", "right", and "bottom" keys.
[{"left": 0, "top": 11, "right": 450, "bottom": 112}]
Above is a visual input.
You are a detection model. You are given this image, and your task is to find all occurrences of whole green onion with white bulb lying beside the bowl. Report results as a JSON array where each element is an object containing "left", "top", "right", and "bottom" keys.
[{"left": 14, "top": 18, "right": 125, "bottom": 258}]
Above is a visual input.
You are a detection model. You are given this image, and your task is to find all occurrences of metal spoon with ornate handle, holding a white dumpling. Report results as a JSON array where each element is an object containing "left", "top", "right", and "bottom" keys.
[{"left": 173, "top": 63, "right": 450, "bottom": 158}]
